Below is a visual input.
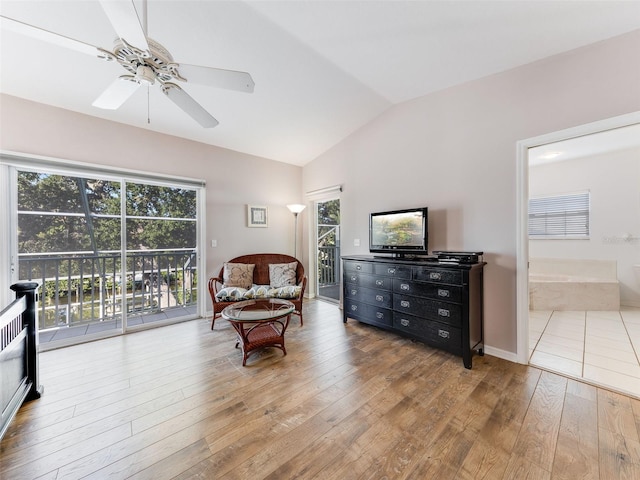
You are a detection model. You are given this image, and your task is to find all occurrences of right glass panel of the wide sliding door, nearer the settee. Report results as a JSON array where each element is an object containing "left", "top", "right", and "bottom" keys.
[{"left": 125, "top": 182, "right": 198, "bottom": 325}]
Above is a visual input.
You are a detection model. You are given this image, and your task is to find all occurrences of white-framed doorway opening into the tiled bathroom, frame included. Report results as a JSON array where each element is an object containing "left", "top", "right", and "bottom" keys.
[{"left": 517, "top": 113, "right": 640, "bottom": 396}]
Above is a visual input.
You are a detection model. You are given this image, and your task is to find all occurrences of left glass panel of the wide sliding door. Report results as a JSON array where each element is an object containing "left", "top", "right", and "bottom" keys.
[{"left": 17, "top": 170, "right": 122, "bottom": 343}]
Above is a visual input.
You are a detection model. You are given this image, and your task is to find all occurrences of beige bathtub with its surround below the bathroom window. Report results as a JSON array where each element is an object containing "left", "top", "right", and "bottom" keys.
[{"left": 529, "top": 258, "right": 620, "bottom": 310}]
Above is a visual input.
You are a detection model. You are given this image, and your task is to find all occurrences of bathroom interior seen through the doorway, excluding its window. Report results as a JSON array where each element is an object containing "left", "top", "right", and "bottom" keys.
[{"left": 529, "top": 125, "right": 640, "bottom": 397}]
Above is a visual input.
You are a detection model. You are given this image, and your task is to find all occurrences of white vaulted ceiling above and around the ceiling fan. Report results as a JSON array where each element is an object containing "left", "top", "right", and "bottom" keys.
[{"left": 0, "top": 0, "right": 640, "bottom": 165}]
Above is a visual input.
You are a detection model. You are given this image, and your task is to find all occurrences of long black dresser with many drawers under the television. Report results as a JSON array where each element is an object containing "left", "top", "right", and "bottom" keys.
[{"left": 342, "top": 255, "right": 486, "bottom": 368}]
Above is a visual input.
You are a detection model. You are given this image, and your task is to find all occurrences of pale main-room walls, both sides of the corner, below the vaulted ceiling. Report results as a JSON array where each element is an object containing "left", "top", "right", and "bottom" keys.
[{"left": 0, "top": 30, "right": 640, "bottom": 355}]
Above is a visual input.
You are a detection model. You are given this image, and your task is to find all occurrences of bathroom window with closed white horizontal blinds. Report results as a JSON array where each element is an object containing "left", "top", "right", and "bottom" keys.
[{"left": 529, "top": 192, "right": 590, "bottom": 239}]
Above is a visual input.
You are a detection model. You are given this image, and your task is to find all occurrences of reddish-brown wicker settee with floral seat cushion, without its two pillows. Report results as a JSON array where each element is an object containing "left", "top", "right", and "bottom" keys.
[{"left": 208, "top": 253, "right": 307, "bottom": 330}]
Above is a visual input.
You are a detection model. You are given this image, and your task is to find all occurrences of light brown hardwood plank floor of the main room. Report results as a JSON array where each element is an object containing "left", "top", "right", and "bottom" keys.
[{"left": 0, "top": 300, "right": 640, "bottom": 480}]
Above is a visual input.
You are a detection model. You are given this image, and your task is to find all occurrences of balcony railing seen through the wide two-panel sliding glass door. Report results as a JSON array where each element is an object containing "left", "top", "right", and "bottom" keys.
[{"left": 19, "top": 249, "right": 197, "bottom": 330}]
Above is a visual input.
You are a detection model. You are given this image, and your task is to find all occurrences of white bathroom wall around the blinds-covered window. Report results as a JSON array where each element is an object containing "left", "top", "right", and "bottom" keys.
[{"left": 529, "top": 148, "right": 640, "bottom": 306}]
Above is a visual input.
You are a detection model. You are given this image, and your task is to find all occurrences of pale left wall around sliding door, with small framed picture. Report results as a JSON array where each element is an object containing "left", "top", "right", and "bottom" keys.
[{"left": 0, "top": 95, "right": 302, "bottom": 308}]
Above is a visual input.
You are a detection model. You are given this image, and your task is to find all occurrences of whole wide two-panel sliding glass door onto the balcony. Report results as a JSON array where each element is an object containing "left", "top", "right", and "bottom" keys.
[{"left": 14, "top": 163, "right": 201, "bottom": 345}]
